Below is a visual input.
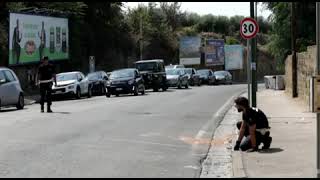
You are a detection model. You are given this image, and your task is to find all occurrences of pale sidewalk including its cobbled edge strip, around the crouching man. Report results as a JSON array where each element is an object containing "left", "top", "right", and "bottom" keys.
[{"left": 200, "top": 89, "right": 316, "bottom": 178}]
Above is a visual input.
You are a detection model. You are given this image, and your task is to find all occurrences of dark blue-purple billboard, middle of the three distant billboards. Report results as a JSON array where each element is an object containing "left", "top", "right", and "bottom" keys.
[{"left": 205, "top": 39, "right": 224, "bottom": 66}]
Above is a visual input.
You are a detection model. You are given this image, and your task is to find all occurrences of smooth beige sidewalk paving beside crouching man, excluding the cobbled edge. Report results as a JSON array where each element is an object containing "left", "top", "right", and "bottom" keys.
[{"left": 241, "top": 90, "right": 316, "bottom": 178}]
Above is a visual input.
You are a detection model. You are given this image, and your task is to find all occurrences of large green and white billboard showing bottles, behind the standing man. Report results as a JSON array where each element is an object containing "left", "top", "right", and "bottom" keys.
[{"left": 9, "top": 13, "right": 69, "bottom": 65}]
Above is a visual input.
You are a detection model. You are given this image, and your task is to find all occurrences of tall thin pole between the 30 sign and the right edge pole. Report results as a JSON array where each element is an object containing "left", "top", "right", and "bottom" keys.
[{"left": 291, "top": 2, "right": 298, "bottom": 98}]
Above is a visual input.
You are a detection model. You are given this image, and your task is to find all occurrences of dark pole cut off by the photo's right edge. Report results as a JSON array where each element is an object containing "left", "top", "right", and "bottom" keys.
[{"left": 313, "top": 2, "right": 320, "bottom": 178}]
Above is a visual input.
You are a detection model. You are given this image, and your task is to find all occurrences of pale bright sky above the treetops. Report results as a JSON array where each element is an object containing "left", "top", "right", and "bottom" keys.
[{"left": 124, "top": 2, "right": 271, "bottom": 18}]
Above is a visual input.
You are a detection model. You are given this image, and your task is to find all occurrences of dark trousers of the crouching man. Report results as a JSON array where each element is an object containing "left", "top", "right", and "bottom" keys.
[{"left": 237, "top": 121, "right": 270, "bottom": 151}]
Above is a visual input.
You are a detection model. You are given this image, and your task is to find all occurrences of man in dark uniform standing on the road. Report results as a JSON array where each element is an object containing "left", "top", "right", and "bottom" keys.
[{"left": 37, "top": 56, "right": 57, "bottom": 113}]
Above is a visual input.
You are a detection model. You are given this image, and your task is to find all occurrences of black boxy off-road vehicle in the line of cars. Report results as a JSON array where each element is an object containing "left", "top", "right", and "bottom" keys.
[{"left": 135, "top": 59, "right": 168, "bottom": 92}]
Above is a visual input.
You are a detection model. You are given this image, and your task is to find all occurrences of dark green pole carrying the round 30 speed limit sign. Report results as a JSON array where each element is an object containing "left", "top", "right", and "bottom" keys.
[{"left": 250, "top": 2, "right": 257, "bottom": 107}]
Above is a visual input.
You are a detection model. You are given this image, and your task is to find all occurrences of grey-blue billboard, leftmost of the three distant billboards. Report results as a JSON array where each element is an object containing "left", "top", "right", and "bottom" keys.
[{"left": 179, "top": 36, "right": 201, "bottom": 65}]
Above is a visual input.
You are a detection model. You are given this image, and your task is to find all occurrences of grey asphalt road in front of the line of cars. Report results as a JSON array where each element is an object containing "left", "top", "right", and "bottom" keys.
[{"left": 0, "top": 85, "right": 246, "bottom": 177}]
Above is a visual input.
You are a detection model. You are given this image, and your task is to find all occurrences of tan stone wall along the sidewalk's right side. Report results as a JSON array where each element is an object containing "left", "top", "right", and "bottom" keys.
[{"left": 285, "top": 46, "right": 317, "bottom": 103}]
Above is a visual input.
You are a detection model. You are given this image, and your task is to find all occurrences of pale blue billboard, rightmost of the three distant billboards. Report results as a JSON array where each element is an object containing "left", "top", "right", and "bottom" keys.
[{"left": 224, "top": 45, "right": 243, "bottom": 70}]
